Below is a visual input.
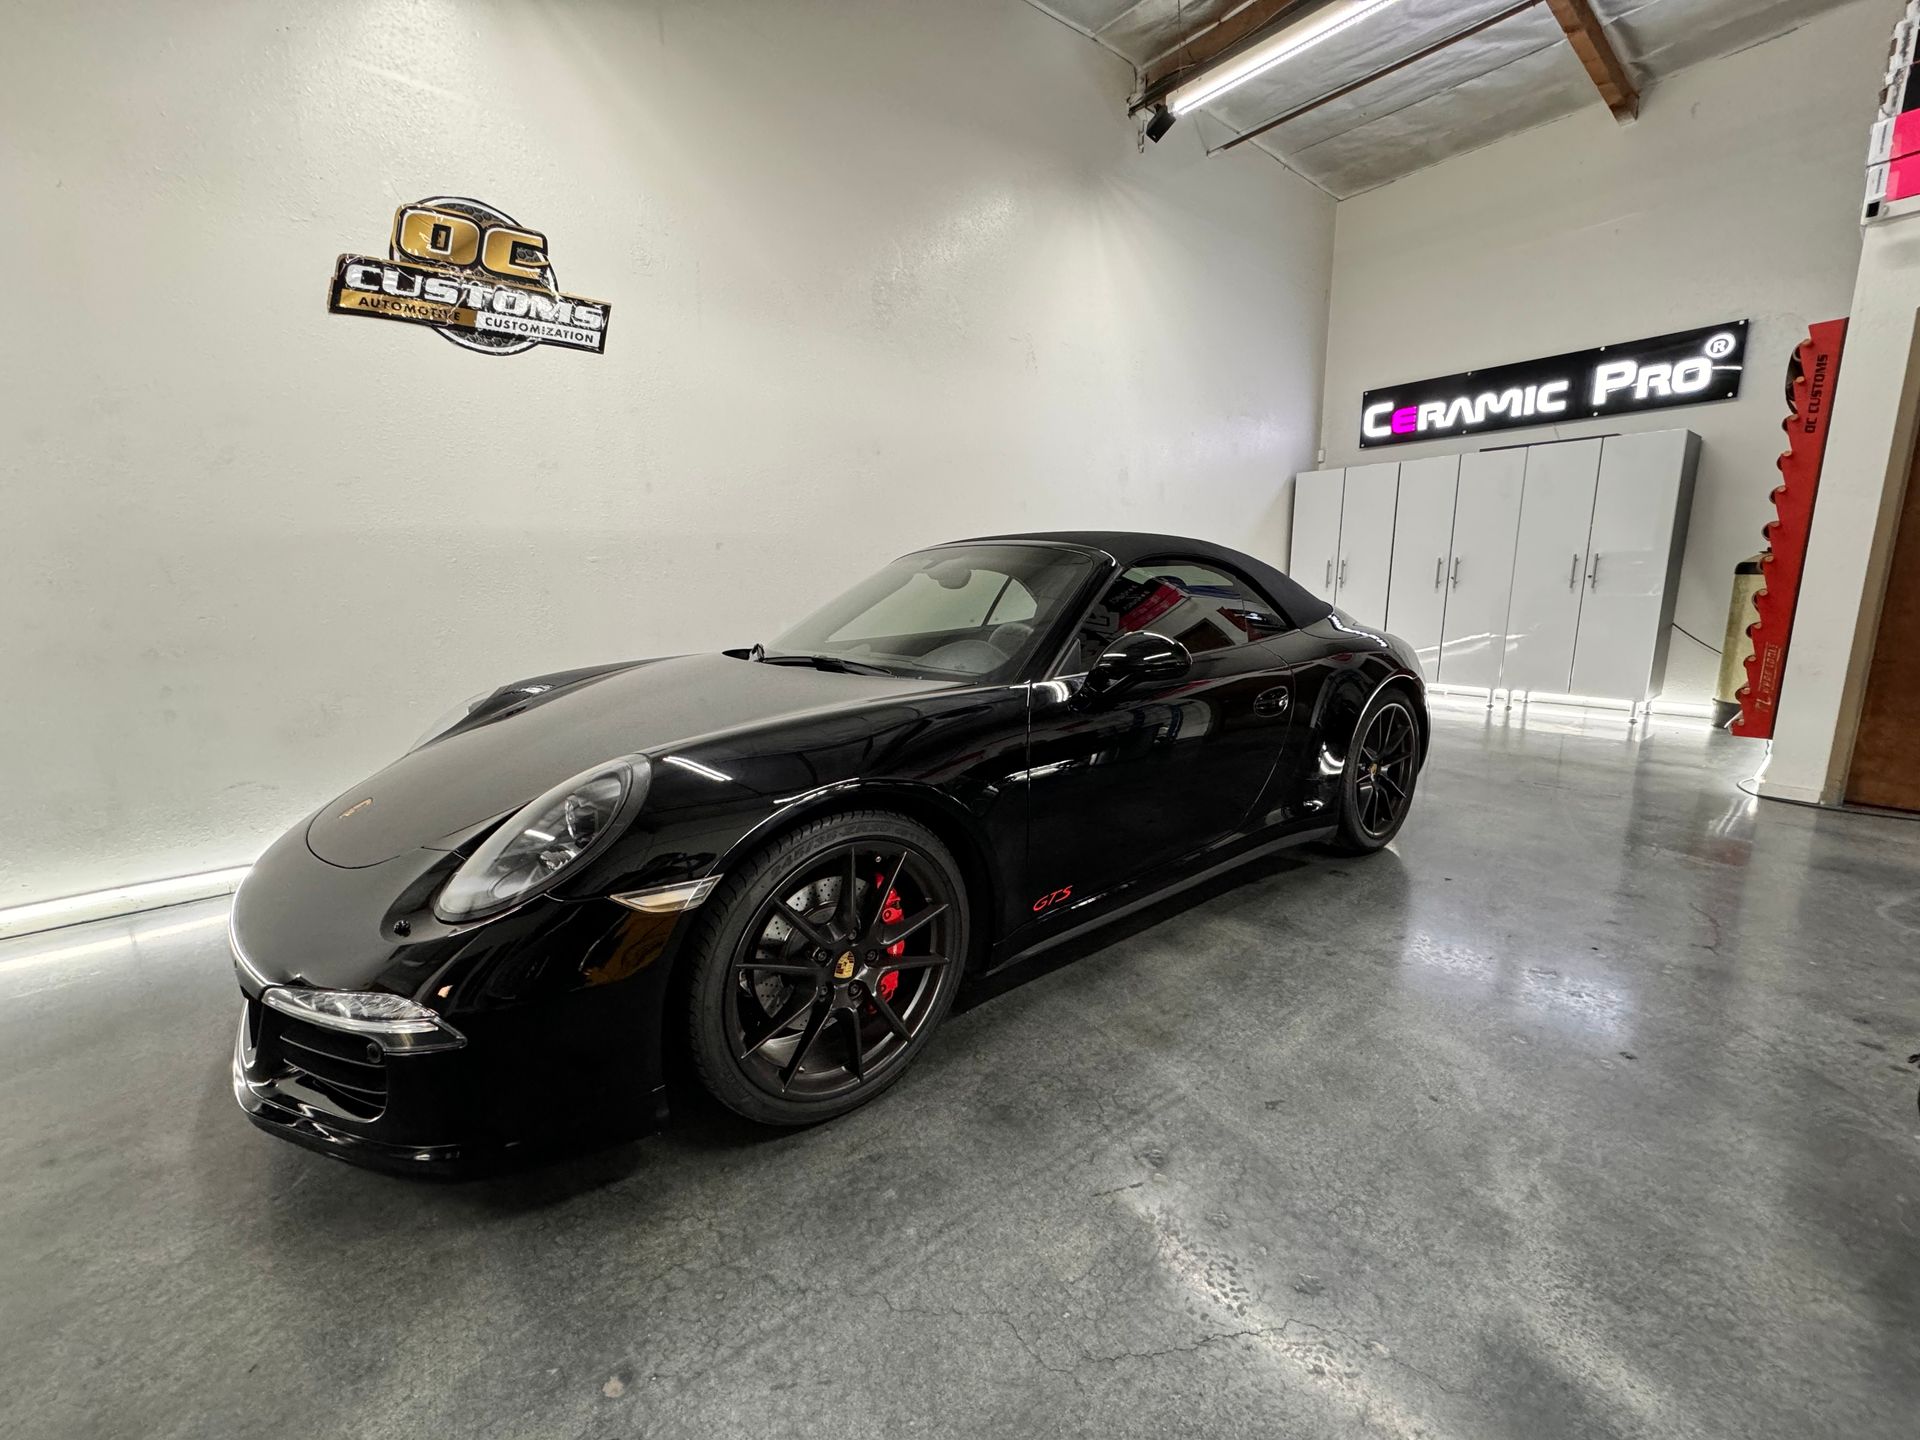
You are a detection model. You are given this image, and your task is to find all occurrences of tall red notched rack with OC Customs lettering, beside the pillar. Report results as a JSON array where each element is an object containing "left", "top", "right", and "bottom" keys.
[{"left": 1728, "top": 321, "right": 1847, "bottom": 739}]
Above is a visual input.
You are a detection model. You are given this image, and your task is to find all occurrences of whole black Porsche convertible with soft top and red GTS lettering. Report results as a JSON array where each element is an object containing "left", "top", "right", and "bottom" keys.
[{"left": 232, "top": 532, "right": 1428, "bottom": 1167}]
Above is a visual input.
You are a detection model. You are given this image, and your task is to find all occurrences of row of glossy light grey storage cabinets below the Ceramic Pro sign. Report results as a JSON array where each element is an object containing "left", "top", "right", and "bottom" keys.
[{"left": 1290, "top": 430, "right": 1699, "bottom": 701}]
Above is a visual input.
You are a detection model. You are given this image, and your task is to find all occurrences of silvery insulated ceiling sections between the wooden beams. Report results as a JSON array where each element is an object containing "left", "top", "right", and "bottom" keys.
[{"left": 1033, "top": 0, "right": 1847, "bottom": 200}]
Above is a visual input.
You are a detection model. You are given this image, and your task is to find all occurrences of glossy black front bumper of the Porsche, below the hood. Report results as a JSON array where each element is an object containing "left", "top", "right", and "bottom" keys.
[{"left": 232, "top": 817, "right": 706, "bottom": 1173}]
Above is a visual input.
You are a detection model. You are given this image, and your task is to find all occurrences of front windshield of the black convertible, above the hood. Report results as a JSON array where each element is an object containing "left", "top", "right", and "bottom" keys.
[{"left": 766, "top": 545, "right": 1098, "bottom": 680}]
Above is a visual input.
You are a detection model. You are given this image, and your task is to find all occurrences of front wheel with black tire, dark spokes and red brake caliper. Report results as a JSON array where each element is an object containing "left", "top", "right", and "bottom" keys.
[{"left": 687, "top": 810, "right": 970, "bottom": 1125}]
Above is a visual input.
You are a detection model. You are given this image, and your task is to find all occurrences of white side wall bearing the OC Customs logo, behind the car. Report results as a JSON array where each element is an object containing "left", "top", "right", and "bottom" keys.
[{"left": 0, "top": 0, "right": 1332, "bottom": 904}]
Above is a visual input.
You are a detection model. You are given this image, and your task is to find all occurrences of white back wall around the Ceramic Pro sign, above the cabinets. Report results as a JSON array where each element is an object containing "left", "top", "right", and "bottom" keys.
[{"left": 1323, "top": 0, "right": 1901, "bottom": 701}]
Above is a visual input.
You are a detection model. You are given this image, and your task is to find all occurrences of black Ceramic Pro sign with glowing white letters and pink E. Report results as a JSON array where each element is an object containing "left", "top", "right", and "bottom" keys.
[{"left": 1359, "top": 321, "right": 1747, "bottom": 449}]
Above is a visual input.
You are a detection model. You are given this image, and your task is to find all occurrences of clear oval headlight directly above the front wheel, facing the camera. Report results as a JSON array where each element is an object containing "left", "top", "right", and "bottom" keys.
[{"left": 434, "top": 755, "right": 653, "bottom": 925}]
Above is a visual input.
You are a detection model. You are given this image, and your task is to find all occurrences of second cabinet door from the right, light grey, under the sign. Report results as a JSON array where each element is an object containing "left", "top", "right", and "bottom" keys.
[{"left": 1500, "top": 440, "right": 1599, "bottom": 695}]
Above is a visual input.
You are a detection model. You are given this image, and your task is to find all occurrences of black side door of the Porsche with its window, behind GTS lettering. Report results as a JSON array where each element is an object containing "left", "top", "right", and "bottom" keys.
[{"left": 1027, "top": 557, "right": 1292, "bottom": 910}]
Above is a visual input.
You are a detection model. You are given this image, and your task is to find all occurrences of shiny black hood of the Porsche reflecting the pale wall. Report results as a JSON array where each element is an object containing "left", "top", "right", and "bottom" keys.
[{"left": 307, "top": 655, "right": 958, "bottom": 870}]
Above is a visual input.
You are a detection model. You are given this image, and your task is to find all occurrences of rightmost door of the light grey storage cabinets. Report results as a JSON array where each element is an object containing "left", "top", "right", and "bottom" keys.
[{"left": 1572, "top": 430, "right": 1692, "bottom": 701}]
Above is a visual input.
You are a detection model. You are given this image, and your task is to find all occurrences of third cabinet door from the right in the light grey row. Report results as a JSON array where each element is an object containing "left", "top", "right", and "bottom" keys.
[{"left": 1440, "top": 449, "right": 1526, "bottom": 689}]
